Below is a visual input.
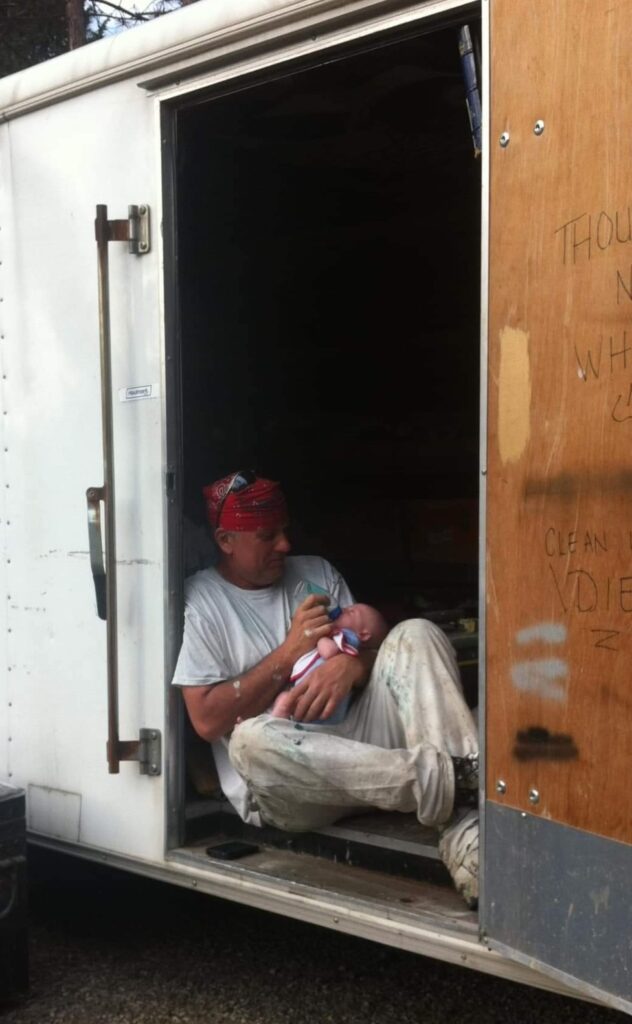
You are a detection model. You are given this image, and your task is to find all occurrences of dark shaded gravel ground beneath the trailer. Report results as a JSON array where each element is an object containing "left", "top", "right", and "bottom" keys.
[{"left": 0, "top": 851, "right": 626, "bottom": 1024}]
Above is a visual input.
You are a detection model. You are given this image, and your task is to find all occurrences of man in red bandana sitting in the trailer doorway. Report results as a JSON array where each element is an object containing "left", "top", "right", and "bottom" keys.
[{"left": 173, "top": 471, "right": 478, "bottom": 906}]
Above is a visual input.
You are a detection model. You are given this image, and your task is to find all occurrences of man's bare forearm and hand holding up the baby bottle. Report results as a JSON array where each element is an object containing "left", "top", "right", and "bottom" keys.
[{"left": 182, "top": 595, "right": 333, "bottom": 741}]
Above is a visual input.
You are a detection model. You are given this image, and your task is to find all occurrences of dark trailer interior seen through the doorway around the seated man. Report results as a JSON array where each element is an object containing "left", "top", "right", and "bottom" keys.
[{"left": 165, "top": 22, "right": 480, "bottom": 912}]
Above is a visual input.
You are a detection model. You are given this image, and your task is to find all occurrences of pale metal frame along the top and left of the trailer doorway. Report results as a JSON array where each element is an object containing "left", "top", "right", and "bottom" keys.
[{"left": 158, "top": 0, "right": 480, "bottom": 850}]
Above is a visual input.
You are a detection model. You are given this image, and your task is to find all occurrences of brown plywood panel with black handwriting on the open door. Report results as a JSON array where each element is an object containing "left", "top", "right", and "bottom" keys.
[{"left": 487, "top": 0, "right": 632, "bottom": 842}]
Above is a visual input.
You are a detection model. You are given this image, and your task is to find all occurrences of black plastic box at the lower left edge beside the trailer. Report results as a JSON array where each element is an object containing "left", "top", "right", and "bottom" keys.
[{"left": 0, "top": 783, "right": 29, "bottom": 1001}]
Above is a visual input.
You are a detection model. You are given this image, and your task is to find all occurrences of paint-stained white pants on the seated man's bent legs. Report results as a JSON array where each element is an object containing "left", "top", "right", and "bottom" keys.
[{"left": 228, "top": 618, "right": 478, "bottom": 831}]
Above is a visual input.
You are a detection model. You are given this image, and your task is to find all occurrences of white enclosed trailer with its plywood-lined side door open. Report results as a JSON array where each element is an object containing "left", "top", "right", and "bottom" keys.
[{"left": 0, "top": 0, "right": 632, "bottom": 1012}]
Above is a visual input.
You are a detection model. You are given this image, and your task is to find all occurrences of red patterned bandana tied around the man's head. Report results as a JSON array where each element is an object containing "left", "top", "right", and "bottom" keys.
[{"left": 202, "top": 473, "right": 288, "bottom": 530}]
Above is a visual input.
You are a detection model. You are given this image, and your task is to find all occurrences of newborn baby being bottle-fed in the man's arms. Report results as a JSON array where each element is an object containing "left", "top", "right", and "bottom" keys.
[{"left": 270, "top": 604, "right": 388, "bottom": 725}]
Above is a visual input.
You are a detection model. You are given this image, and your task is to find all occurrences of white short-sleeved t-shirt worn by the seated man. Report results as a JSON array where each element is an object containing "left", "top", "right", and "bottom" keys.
[{"left": 173, "top": 555, "right": 353, "bottom": 824}]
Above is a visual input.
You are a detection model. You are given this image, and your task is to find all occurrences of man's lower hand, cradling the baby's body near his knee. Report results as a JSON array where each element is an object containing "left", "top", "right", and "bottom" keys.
[{"left": 283, "top": 654, "right": 367, "bottom": 722}]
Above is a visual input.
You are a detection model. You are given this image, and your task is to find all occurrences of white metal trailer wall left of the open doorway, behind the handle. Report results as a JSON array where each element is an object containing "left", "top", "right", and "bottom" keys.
[{"left": 0, "top": 82, "right": 164, "bottom": 859}]
